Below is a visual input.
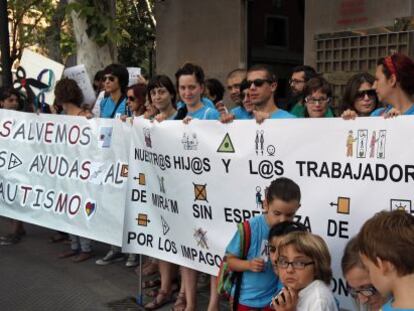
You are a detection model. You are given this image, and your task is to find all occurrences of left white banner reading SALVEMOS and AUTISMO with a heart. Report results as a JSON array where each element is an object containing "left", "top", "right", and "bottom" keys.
[{"left": 0, "top": 109, "right": 130, "bottom": 245}]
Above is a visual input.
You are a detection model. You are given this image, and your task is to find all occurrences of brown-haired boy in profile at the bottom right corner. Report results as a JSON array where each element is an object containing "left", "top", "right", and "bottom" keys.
[{"left": 358, "top": 210, "right": 414, "bottom": 311}]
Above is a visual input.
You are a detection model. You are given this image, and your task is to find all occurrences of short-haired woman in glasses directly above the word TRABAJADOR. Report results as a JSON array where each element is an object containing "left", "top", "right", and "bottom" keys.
[{"left": 303, "top": 76, "right": 334, "bottom": 118}]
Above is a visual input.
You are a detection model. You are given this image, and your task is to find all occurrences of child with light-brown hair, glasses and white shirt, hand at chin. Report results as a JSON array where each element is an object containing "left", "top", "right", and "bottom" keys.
[{"left": 272, "top": 232, "right": 338, "bottom": 311}]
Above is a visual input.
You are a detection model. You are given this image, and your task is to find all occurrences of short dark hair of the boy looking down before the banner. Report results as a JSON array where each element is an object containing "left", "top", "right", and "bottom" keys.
[{"left": 266, "top": 177, "right": 301, "bottom": 203}]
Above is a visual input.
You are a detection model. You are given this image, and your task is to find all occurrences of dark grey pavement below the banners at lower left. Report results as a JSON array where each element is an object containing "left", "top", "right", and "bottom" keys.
[{"left": 0, "top": 217, "right": 227, "bottom": 311}]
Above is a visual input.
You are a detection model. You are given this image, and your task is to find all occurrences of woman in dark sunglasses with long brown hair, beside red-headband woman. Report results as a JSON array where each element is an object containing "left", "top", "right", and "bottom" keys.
[{"left": 341, "top": 72, "right": 380, "bottom": 117}]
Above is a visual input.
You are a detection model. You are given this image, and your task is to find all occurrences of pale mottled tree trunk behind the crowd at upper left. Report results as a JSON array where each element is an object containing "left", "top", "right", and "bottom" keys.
[{"left": 69, "top": 0, "right": 117, "bottom": 81}]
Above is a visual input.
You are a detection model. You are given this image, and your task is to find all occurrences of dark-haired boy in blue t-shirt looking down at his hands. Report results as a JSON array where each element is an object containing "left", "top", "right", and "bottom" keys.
[{"left": 226, "top": 177, "right": 301, "bottom": 311}]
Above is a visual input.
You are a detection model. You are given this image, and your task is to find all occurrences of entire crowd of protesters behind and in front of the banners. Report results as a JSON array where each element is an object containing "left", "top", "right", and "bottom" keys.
[{"left": 0, "top": 54, "right": 414, "bottom": 311}]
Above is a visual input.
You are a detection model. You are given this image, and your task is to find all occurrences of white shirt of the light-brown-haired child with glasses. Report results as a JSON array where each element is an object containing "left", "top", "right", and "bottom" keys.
[{"left": 296, "top": 280, "right": 338, "bottom": 311}]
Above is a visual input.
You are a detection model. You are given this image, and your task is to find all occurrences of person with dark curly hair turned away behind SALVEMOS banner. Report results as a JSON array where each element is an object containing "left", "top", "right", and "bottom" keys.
[{"left": 54, "top": 78, "right": 93, "bottom": 263}]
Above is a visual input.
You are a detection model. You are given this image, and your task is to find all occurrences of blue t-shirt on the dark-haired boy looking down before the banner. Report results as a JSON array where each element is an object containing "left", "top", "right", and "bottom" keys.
[{"left": 226, "top": 215, "right": 278, "bottom": 308}]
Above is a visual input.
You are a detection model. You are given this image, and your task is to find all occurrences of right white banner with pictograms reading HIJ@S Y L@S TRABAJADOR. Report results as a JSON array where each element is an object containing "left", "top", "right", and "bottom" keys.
[{"left": 123, "top": 117, "right": 414, "bottom": 309}]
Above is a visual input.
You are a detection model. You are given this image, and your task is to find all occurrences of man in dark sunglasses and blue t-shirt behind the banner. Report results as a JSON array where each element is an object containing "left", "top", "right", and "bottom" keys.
[{"left": 246, "top": 65, "right": 295, "bottom": 123}]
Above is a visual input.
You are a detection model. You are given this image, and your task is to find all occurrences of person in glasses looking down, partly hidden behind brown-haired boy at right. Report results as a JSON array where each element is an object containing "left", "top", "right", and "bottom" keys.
[{"left": 341, "top": 238, "right": 386, "bottom": 311}]
